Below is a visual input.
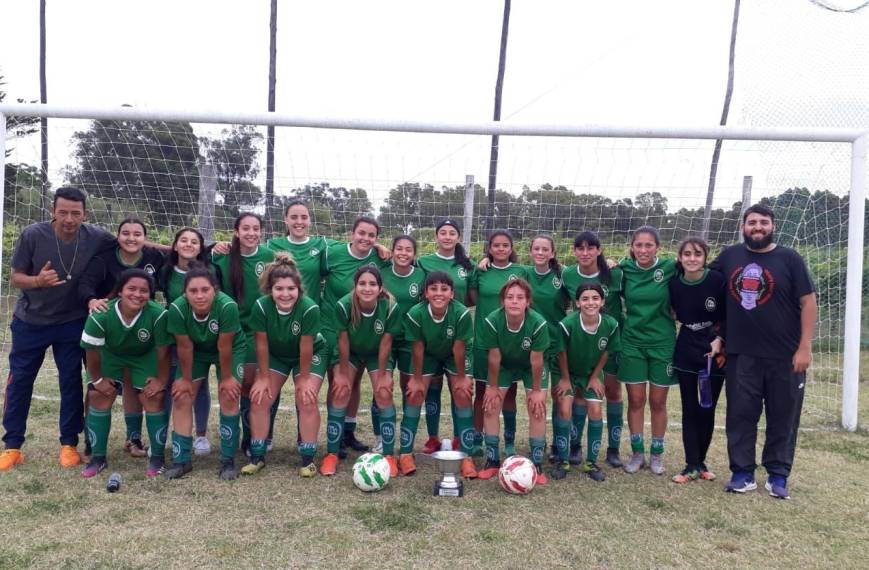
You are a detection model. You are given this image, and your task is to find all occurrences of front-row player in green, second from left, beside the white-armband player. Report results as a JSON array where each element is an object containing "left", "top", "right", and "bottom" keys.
[{"left": 166, "top": 263, "right": 247, "bottom": 479}]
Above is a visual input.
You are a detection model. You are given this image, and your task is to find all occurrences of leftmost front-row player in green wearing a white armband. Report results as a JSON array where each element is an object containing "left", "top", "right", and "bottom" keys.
[{"left": 81, "top": 269, "right": 172, "bottom": 477}]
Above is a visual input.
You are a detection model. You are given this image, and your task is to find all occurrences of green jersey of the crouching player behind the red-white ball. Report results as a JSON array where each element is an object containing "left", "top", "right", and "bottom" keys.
[{"left": 477, "top": 309, "right": 549, "bottom": 371}]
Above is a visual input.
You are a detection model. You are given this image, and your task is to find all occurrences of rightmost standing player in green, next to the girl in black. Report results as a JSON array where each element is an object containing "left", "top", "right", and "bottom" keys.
[{"left": 619, "top": 226, "right": 677, "bottom": 475}]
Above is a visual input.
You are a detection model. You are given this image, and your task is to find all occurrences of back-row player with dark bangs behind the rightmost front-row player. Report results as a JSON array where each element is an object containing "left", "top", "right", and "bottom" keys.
[{"left": 561, "top": 232, "right": 624, "bottom": 468}]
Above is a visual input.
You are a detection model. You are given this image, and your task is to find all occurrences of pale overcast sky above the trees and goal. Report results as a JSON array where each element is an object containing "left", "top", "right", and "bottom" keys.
[{"left": 0, "top": 0, "right": 869, "bottom": 217}]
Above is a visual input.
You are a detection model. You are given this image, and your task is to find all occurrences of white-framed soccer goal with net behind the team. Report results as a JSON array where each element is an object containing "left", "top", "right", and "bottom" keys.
[{"left": 0, "top": 105, "right": 869, "bottom": 430}]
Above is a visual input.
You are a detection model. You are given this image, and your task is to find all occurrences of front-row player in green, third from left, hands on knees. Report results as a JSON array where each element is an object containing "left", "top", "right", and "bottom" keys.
[{"left": 241, "top": 253, "right": 328, "bottom": 477}]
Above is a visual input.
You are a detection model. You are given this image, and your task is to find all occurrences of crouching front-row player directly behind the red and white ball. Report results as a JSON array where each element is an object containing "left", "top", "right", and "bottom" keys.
[{"left": 477, "top": 279, "right": 550, "bottom": 485}]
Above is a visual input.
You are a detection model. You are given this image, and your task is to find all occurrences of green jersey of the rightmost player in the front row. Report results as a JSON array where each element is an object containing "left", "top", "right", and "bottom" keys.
[{"left": 558, "top": 311, "right": 621, "bottom": 380}]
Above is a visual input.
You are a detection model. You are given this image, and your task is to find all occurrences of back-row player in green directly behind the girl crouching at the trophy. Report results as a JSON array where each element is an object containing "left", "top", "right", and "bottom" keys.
[{"left": 418, "top": 218, "right": 475, "bottom": 453}]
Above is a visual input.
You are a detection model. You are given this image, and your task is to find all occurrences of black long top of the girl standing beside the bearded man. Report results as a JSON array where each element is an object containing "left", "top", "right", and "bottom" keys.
[{"left": 670, "top": 269, "right": 724, "bottom": 372}]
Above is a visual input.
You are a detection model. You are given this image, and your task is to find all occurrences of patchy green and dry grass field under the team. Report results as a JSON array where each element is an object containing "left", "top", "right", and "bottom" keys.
[{"left": 0, "top": 358, "right": 869, "bottom": 568}]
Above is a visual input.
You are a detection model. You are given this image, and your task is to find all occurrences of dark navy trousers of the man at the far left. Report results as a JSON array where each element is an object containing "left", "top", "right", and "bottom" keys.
[{"left": 3, "top": 318, "right": 85, "bottom": 449}]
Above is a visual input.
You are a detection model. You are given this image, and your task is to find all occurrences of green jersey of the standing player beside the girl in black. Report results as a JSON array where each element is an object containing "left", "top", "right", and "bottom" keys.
[{"left": 619, "top": 258, "right": 676, "bottom": 348}]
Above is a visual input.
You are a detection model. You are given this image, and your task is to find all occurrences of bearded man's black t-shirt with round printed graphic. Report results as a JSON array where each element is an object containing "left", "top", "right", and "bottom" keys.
[{"left": 710, "top": 245, "right": 815, "bottom": 359}]
